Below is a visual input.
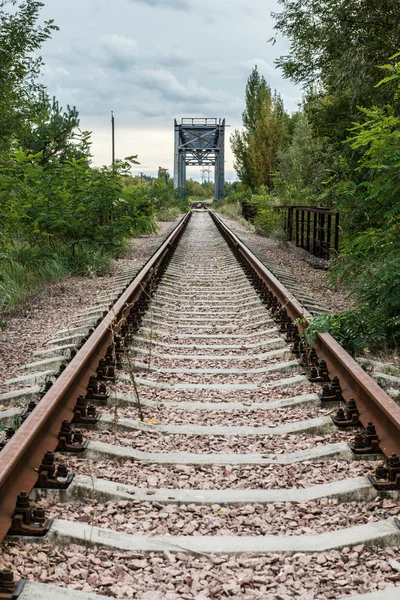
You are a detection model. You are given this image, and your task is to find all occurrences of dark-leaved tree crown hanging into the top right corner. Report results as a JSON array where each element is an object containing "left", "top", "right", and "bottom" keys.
[{"left": 273, "top": 0, "right": 400, "bottom": 142}]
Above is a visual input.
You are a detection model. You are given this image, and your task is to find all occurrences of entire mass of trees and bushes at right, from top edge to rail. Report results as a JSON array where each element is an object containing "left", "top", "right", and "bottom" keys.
[{"left": 266, "top": 0, "right": 400, "bottom": 352}]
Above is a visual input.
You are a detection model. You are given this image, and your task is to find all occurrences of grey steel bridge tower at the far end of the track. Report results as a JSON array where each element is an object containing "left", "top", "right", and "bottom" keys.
[{"left": 174, "top": 118, "right": 225, "bottom": 201}]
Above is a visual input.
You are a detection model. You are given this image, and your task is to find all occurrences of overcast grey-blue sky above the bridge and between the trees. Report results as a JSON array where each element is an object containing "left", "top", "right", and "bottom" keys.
[{"left": 42, "top": 0, "right": 301, "bottom": 180}]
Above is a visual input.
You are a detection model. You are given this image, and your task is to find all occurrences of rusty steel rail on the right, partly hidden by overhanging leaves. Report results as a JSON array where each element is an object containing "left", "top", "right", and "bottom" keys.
[{"left": 209, "top": 210, "right": 400, "bottom": 457}]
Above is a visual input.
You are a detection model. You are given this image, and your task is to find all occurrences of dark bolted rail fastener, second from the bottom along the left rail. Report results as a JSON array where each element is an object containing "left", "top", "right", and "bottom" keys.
[{"left": 7, "top": 492, "right": 53, "bottom": 537}]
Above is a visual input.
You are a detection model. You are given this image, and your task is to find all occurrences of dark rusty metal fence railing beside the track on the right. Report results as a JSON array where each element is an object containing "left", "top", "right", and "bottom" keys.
[{"left": 286, "top": 206, "right": 339, "bottom": 260}]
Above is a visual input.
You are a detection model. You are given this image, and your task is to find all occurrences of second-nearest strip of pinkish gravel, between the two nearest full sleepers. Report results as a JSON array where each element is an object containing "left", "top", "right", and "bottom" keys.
[{"left": 38, "top": 498, "right": 400, "bottom": 536}]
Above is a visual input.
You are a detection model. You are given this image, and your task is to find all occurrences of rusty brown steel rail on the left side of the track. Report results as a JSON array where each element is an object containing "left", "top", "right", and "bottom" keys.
[{"left": 0, "top": 212, "right": 191, "bottom": 541}]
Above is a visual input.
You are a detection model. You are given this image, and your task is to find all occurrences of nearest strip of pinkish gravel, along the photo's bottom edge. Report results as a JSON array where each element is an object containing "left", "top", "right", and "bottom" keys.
[{"left": 0, "top": 541, "right": 400, "bottom": 600}]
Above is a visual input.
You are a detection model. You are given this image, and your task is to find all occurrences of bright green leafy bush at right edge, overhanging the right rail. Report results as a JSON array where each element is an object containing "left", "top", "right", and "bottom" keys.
[{"left": 304, "top": 55, "right": 400, "bottom": 351}]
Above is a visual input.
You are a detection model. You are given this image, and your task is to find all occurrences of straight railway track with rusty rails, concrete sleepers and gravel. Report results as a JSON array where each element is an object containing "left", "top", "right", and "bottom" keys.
[{"left": 0, "top": 209, "right": 400, "bottom": 600}]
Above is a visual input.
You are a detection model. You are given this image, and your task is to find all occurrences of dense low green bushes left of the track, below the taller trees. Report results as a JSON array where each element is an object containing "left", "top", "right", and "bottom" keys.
[{"left": 0, "top": 149, "right": 147, "bottom": 251}]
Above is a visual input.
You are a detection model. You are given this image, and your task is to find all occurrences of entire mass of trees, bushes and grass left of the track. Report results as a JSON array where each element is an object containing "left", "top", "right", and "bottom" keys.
[{"left": 0, "top": 0, "right": 185, "bottom": 312}]
